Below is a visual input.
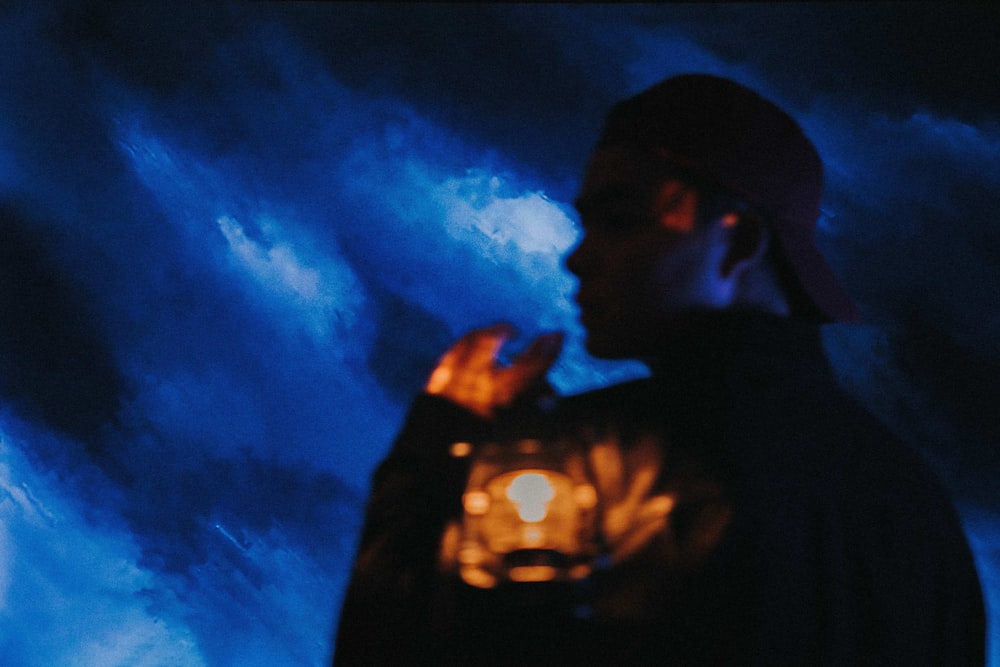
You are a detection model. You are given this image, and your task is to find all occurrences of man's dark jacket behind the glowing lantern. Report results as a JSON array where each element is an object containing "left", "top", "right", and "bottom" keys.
[{"left": 334, "top": 315, "right": 985, "bottom": 667}]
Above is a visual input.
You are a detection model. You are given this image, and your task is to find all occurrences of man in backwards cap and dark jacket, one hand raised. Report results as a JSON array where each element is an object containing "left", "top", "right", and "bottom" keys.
[{"left": 335, "top": 75, "right": 984, "bottom": 665}]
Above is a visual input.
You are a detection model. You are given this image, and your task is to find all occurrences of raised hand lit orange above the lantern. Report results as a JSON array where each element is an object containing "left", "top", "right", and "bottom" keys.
[{"left": 424, "top": 324, "right": 563, "bottom": 418}]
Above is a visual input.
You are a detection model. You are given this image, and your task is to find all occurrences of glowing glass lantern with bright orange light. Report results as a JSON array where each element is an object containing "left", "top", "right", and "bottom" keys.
[{"left": 443, "top": 439, "right": 597, "bottom": 588}]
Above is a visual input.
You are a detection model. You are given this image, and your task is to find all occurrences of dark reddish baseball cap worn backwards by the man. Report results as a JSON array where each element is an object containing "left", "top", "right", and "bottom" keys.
[{"left": 598, "top": 74, "right": 859, "bottom": 321}]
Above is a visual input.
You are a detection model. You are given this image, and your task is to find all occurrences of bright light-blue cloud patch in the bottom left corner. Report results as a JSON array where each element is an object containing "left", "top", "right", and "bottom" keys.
[{"left": 0, "top": 421, "right": 206, "bottom": 667}]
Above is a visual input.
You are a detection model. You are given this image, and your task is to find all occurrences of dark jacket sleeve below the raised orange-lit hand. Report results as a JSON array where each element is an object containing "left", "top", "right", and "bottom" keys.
[{"left": 333, "top": 395, "right": 485, "bottom": 667}]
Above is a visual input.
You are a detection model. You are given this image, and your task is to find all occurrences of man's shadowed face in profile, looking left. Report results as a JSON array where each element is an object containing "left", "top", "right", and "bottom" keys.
[{"left": 566, "top": 147, "right": 725, "bottom": 358}]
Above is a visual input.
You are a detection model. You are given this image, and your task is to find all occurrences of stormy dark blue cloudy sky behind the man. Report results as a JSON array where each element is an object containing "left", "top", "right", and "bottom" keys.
[{"left": 0, "top": 2, "right": 1000, "bottom": 667}]
